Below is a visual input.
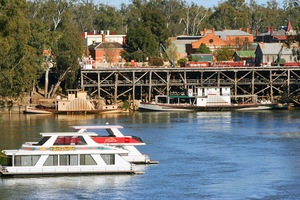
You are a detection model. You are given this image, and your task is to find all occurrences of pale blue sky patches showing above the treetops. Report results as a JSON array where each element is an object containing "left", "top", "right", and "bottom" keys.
[{"left": 94, "top": 0, "right": 284, "bottom": 9}]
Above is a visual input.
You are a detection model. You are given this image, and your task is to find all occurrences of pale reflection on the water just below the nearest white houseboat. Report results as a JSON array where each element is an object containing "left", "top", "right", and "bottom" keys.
[{"left": 0, "top": 175, "right": 135, "bottom": 199}]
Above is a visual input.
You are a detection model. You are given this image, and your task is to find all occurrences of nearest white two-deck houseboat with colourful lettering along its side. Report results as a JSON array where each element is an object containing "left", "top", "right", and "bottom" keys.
[{"left": 0, "top": 127, "right": 146, "bottom": 175}]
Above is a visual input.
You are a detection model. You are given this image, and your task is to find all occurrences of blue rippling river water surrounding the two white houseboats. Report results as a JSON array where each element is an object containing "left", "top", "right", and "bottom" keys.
[{"left": 0, "top": 111, "right": 300, "bottom": 200}]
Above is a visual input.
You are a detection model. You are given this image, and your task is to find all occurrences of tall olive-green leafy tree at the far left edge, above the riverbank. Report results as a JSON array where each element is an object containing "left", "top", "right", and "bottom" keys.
[{"left": 0, "top": 0, "right": 38, "bottom": 99}]
